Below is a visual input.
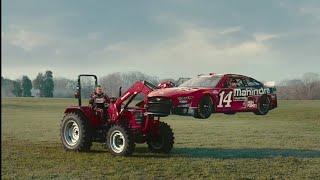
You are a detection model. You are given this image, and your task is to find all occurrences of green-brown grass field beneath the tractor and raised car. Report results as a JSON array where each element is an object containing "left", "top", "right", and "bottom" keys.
[{"left": 1, "top": 98, "right": 320, "bottom": 179}]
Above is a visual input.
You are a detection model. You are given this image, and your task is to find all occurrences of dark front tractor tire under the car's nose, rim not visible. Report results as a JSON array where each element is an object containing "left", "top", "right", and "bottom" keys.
[{"left": 147, "top": 122, "right": 174, "bottom": 154}]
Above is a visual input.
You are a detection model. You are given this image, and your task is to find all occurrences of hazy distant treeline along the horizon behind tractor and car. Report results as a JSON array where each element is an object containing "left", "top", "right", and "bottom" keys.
[{"left": 1, "top": 71, "right": 320, "bottom": 99}]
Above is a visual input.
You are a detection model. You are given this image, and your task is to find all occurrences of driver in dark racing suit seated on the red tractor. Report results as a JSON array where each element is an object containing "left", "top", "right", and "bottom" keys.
[{"left": 89, "top": 85, "right": 110, "bottom": 120}]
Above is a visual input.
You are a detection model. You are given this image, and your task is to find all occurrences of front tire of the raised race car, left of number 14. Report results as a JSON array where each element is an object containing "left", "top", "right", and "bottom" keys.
[{"left": 194, "top": 96, "right": 214, "bottom": 119}]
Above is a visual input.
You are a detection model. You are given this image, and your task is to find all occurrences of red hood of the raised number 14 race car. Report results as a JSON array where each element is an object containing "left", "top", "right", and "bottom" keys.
[{"left": 148, "top": 87, "right": 205, "bottom": 97}]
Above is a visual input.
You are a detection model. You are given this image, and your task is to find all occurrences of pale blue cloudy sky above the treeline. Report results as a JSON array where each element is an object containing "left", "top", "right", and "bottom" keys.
[{"left": 1, "top": 0, "right": 320, "bottom": 80}]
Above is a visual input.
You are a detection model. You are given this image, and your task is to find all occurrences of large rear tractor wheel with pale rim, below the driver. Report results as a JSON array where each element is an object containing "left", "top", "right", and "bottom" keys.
[{"left": 60, "top": 113, "right": 92, "bottom": 152}]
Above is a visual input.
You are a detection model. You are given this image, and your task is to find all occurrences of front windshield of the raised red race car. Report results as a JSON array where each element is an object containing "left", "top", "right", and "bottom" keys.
[{"left": 179, "top": 75, "right": 222, "bottom": 87}]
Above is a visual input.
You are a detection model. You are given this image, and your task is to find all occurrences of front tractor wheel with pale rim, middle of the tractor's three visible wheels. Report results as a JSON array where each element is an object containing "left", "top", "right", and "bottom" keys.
[{"left": 106, "top": 125, "right": 135, "bottom": 156}]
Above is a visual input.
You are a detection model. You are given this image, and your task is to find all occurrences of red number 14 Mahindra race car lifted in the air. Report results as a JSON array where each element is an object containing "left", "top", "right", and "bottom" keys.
[{"left": 148, "top": 73, "right": 277, "bottom": 119}]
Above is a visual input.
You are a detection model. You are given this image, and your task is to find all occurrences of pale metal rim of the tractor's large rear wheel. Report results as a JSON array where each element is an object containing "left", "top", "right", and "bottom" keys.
[{"left": 64, "top": 121, "right": 80, "bottom": 146}]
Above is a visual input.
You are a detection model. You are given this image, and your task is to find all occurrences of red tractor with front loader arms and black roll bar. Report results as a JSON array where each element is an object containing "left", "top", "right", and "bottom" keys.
[{"left": 60, "top": 74, "right": 174, "bottom": 156}]
